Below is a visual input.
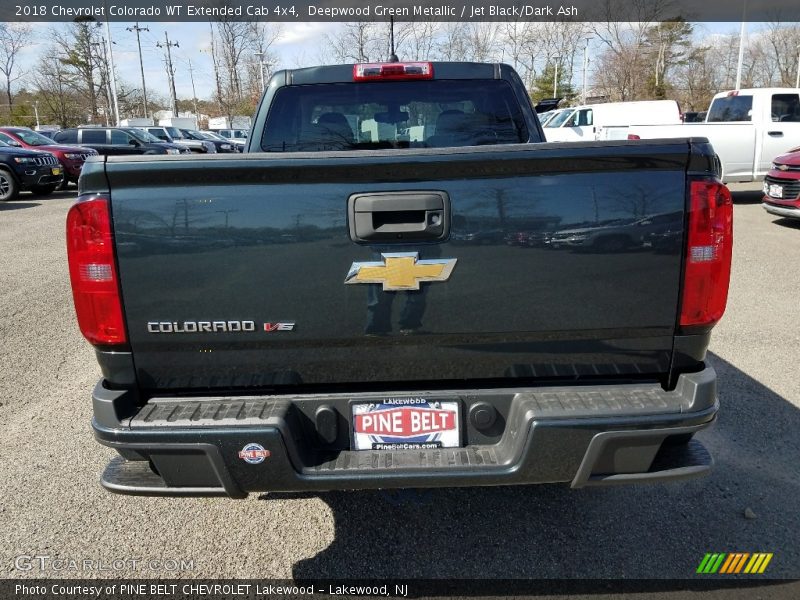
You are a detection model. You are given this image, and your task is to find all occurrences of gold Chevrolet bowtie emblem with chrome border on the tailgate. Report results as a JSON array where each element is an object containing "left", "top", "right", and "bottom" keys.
[{"left": 344, "top": 252, "right": 457, "bottom": 292}]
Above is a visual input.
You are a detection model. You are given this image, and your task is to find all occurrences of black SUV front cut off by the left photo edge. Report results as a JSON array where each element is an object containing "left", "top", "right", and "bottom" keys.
[{"left": 0, "top": 141, "right": 64, "bottom": 201}]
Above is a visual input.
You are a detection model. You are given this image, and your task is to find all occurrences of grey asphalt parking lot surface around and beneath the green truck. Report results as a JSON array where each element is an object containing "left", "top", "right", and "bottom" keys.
[{"left": 0, "top": 186, "right": 800, "bottom": 584}]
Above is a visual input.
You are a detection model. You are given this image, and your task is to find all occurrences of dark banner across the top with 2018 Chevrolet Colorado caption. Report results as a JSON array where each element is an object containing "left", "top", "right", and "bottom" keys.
[{"left": 0, "top": 0, "right": 800, "bottom": 23}]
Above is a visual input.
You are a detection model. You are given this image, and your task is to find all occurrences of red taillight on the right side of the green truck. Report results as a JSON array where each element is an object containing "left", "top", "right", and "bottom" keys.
[{"left": 680, "top": 180, "right": 733, "bottom": 327}]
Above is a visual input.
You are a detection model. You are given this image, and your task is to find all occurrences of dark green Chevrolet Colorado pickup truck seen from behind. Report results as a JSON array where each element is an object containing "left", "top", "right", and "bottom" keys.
[{"left": 67, "top": 62, "right": 732, "bottom": 497}]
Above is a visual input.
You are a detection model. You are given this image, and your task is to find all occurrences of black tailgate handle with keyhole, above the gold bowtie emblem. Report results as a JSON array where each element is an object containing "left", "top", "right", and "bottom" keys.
[{"left": 347, "top": 191, "right": 450, "bottom": 244}]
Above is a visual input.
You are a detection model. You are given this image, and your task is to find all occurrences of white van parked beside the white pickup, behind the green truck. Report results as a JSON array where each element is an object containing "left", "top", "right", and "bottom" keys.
[{"left": 544, "top": 100, "right": 681, "bottom": 142}]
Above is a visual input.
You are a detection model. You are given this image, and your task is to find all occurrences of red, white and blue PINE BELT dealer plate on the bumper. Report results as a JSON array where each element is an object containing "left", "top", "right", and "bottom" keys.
[{"left": 352, "top": 398, "right": 461, "bottom": 450}]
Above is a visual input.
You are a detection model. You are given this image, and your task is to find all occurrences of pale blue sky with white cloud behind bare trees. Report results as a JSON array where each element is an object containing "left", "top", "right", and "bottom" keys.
[{"left": 15, "top": 20, "right": 760, "bottom": 99}]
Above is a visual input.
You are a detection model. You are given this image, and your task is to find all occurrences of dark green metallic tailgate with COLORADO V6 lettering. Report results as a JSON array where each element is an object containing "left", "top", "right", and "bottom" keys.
[{"left": 106, "top": 140, "right": 689, "bottom": 390}]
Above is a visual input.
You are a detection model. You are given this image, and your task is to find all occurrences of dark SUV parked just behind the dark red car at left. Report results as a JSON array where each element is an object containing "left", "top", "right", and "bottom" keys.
[{"left": 54, "top": 127, "right": 191, "bottom": 155}]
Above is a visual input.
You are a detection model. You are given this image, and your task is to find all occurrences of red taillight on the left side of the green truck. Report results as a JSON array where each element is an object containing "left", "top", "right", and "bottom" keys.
[{"left": 67, "top": 196, "right": 127, "bottom": 345}]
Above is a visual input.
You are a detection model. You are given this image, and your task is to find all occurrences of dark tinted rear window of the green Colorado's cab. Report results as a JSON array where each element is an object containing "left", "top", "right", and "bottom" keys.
[{"left": 261, "top": 80, "right": 528, "bottom": 152}]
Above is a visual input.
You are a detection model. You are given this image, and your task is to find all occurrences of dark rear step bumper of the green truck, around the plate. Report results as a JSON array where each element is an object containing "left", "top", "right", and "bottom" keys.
[{"left": 93, "top": 367, "right": 718, "bottom": 498}]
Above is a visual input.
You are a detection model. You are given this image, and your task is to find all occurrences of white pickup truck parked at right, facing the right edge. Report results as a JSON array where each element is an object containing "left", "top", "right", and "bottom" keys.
[{"left": 628, "top": 88, "right": 800, "bottom": 183}]
